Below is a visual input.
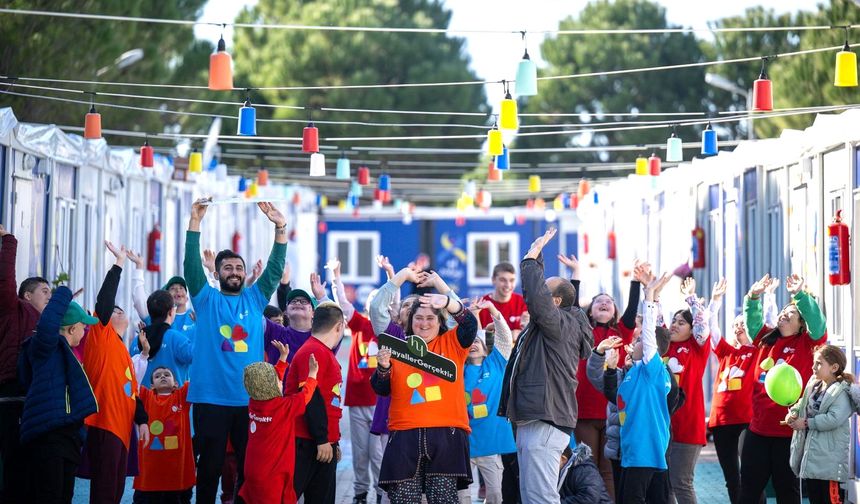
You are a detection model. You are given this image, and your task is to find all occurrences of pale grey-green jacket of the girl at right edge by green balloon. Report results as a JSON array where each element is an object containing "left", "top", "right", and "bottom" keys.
[{"left": 789, "top": 378, "right": 854, "bottom": 481}]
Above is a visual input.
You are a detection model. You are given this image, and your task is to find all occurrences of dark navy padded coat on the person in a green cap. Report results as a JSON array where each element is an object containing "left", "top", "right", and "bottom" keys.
[{"left": 18, "top": 287, "right": 98, "bottom": 444}]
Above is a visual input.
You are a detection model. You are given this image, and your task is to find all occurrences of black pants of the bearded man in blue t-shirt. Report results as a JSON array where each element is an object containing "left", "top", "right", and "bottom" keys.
[{"left": 193, "top": 403, "right": 248, "bottom": 504}]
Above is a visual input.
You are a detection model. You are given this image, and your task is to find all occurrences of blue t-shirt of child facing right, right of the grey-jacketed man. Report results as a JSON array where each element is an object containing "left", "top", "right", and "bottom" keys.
[{"left": 617, "top": 355, "right": 672, "bottom": 469}]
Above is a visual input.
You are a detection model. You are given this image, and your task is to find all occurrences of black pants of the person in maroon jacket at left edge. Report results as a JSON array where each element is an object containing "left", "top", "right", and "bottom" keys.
[{"left": 0, "top": 401, "right": 24, "bottom": 504}]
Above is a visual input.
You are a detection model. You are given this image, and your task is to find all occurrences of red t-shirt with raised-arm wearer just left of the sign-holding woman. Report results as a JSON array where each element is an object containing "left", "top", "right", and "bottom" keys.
[{"left": 343, "top": 311, "right": 379, "bottom": 406}]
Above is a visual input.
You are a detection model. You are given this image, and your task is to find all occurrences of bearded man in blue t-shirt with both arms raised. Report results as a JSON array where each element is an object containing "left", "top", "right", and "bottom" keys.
[{"left": 184, "top": 200, "right": 287, "bottom": 504}]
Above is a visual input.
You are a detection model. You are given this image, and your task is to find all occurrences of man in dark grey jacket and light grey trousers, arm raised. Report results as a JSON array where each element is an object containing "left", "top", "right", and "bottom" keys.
[{"left": 499, "top": 229, "right": 594, "bottom": 504}]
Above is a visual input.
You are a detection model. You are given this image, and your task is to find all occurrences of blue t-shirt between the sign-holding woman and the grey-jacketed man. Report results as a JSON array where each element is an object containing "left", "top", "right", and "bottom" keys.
[{"left": 463, "top": 348, "right": 517, "bottom": 457}]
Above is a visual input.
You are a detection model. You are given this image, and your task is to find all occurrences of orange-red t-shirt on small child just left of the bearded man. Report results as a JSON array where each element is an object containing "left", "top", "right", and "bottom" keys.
[{"left": 134, "top": 382, "right": 196, "bottom": 492}]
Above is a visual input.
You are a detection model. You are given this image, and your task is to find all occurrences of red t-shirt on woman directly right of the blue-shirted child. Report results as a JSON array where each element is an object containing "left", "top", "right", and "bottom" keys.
[{"left": 665, "top": 336, "right": 711, "bottom": 446}]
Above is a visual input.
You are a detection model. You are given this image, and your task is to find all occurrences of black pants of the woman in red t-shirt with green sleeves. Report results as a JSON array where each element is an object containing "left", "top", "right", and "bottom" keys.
[{"left": 740, "top": 430, "right": 800, "bottom": 504}]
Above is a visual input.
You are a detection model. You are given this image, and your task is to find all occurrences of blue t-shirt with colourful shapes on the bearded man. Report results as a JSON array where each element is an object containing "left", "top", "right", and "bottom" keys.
[{"left": 188, "top": 284, "right": 268, "bottom": 406}]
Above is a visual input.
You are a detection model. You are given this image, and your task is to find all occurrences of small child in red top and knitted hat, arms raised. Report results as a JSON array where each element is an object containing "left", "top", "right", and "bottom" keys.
[{"left": 239, "top": 340, "right": 320, "bottom": 504}]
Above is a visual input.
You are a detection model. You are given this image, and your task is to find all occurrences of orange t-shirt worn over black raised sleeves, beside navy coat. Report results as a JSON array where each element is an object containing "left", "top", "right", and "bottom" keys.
[{"left": 83, "top": 322, "right": 137, "bottom": 449}]
